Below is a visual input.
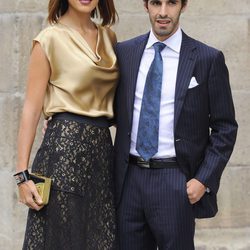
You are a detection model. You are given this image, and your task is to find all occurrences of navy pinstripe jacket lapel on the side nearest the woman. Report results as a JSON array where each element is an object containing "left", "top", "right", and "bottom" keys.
[{"left": 126, "top": 33, "right": 149, "bottom": 125}]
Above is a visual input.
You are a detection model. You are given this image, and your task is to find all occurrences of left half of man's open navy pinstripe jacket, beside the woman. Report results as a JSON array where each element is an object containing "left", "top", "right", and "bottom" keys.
[{"left": 114, "top": 33, "right": 149, "bottom": 207}]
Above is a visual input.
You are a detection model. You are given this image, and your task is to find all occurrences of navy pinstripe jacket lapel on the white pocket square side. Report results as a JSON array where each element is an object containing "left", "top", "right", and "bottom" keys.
[{"left": 174, "top": 33, "right": 197, "bottom": 128}]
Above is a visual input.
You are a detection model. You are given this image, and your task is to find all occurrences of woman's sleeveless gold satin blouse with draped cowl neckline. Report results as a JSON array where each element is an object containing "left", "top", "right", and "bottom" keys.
[{"left": 33, "top": 23, "right": 118, "bottom": 118}]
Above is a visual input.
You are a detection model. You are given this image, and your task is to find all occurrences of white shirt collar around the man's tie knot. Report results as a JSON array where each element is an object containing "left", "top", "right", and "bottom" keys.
[{"left": 146, "top": 27, "right": 182, "bottom": 53}]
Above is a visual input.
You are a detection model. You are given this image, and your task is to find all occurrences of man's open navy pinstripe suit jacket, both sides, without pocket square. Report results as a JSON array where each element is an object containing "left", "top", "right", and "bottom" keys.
[{"left": 114, "top": 32, "right": 238, "bottom": 218}]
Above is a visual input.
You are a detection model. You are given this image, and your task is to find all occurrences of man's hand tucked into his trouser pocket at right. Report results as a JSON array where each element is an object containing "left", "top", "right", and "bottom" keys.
[{"left": 187, "top": 179, "right": 206, "bottom": 204}]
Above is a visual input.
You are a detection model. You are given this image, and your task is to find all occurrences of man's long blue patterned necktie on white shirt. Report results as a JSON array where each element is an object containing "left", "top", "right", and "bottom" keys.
[{"left": 136, "top": 42, "right": 166, "bottom": 161}]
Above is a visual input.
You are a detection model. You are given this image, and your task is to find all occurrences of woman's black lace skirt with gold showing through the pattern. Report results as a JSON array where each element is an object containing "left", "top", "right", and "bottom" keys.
[{"left": 23, "top": 113, "right": 117, "bottom": 250}]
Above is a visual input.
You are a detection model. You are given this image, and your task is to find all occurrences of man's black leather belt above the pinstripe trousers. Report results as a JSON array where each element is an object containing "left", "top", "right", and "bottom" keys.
[{"left": 129, "top": 155, "right": 179, "bottom": 168}]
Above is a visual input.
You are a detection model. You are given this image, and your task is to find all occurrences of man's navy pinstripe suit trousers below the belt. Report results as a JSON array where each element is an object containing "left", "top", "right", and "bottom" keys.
[{"left": 118, "top": 165, "right": 194, "bottom": 250}]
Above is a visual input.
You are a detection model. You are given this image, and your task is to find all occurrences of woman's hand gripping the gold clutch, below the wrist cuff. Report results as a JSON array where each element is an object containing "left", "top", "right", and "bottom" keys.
[{"left": 18, "top": 180, "right": 44, "bottom": 211}]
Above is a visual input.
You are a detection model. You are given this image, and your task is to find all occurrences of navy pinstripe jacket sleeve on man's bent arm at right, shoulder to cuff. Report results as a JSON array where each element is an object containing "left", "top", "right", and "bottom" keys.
[{"left": 195, "top": 52, "right": 238, "bottom": 193}]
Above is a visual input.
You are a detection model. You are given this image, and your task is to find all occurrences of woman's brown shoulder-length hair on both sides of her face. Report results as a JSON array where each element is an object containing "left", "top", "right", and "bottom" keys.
[{"left": 48, "top": 0, "right": 118, "bottom": 26}]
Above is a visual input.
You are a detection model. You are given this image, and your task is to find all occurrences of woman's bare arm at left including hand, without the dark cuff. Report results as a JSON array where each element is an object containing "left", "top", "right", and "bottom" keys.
[{"left": 16, "top": 42, "right": 50, "bottom": 210}]
